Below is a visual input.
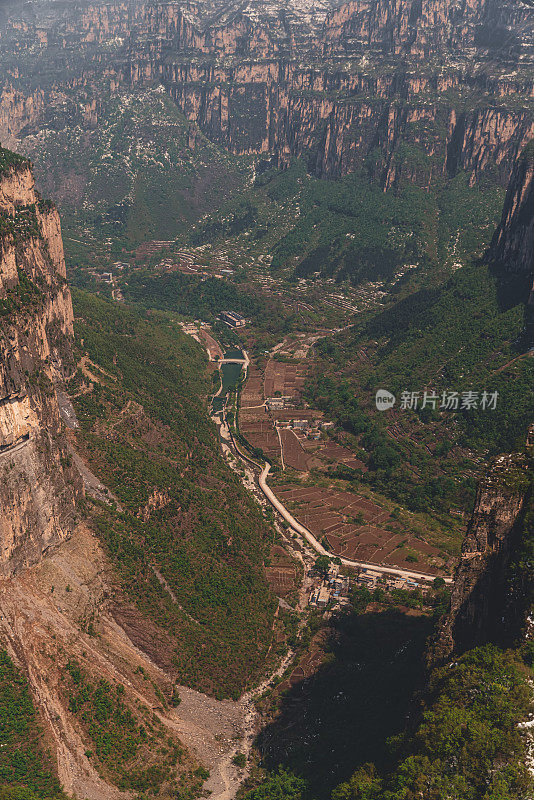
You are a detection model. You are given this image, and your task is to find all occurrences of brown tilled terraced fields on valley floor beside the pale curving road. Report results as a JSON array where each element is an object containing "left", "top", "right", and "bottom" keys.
[{"left": 239, "top": 360, "right": 448, "bottom": 576}]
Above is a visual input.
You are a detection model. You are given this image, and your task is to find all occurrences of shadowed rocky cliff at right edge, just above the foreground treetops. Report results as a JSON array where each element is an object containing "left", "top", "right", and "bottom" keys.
[{"left": 430, "top": 446, "right": 534, "bottom": 662}]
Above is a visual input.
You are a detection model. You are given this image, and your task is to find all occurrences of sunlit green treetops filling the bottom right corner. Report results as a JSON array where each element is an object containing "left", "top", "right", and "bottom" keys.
[{"left": 332, "top": 645, "right": 532, "bottom": 800}]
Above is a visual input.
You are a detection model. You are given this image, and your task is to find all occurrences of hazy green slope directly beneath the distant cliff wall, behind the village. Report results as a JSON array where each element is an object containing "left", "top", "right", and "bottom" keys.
[{"left": 185, "top": 162, "right": 503, "bottom": 289}]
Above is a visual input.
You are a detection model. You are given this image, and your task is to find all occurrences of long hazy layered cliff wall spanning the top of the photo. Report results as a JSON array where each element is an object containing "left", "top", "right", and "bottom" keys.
[{"left": 0, "top": 0, "right": 534, "bottom": 188}]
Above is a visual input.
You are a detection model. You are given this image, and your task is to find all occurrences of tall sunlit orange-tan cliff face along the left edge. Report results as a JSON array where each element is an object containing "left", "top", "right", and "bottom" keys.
[{"left": 0, "top": 150, "right": 81, "bottom": 575}]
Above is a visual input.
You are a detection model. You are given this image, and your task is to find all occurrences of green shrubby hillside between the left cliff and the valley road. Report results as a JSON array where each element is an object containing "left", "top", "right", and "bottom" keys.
[{"left": 72, "top": 292, "right": 275, "bottom": 696}]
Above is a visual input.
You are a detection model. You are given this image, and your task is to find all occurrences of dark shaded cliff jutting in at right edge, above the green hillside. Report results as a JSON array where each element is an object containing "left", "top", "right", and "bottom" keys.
[{"left": 490, "top": 140, "right": 534, "bottom": 304}]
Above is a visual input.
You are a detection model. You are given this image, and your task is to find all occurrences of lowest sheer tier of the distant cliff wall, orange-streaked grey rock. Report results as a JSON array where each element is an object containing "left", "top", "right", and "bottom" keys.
[{"left": 163, "top": 69, "right": 534, "bottom": 188}]
